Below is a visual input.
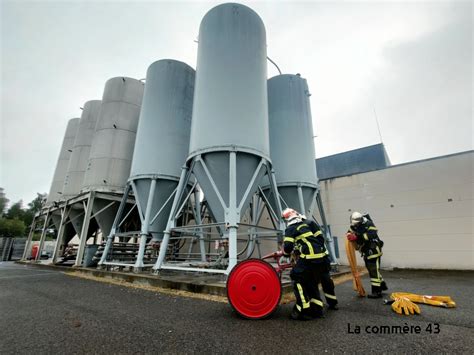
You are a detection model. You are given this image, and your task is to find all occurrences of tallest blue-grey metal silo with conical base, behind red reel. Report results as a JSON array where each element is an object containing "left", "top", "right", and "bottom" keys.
[{"left": 155, "top": 3, "right": 284, "bottom": 272}]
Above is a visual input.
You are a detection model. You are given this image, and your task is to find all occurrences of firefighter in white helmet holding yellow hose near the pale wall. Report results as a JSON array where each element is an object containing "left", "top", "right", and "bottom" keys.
[{"left": 347, "top": 212, "right": 388, "bottom": 298}]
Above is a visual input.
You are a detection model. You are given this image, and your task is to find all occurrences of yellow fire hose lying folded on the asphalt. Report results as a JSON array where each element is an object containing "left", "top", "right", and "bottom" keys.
[{"left": 390, "top": 292, "right": 456, "bottom": 315}]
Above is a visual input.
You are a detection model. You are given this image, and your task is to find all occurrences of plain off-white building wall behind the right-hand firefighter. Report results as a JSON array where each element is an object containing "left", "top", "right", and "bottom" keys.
[{"left": 320, "top": 151, "right": 474, "bottom": 270}]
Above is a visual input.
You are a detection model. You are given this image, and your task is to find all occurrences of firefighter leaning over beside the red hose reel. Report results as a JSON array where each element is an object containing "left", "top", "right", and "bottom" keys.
[{"left": 282, "top": 208, "right": 337, "bottom": 320}]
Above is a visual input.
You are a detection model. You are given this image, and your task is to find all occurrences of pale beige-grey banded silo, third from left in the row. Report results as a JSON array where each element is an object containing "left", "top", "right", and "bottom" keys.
[{"left": 81, "top": 77, "right": 144, "bottom": 239}]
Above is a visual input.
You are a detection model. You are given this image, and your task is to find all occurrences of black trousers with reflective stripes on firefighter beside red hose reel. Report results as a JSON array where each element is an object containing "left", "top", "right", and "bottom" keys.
[{"left": 290, "top": 259, "right": 324, "bottom": 315}]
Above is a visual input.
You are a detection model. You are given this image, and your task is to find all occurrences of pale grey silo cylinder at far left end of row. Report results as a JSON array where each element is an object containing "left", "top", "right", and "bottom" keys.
[{"left": 46, "top": 118, "right": 79, "bottom": 204}]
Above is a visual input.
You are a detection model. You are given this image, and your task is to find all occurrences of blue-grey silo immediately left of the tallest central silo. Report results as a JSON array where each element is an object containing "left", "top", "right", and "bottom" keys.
[{"left": 101, "top": 59, "right": 195, "bottom": 268}]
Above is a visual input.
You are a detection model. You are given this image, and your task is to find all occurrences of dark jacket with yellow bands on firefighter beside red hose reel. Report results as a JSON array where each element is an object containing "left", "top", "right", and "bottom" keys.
[{"left": 283, "top": 219, "right": 329, "bottom": 262}]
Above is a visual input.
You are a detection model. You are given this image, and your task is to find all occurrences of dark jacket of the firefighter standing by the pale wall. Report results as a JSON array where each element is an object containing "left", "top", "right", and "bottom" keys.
[{"left": 348, "top": 219, "right": 383, "bottom": 259}]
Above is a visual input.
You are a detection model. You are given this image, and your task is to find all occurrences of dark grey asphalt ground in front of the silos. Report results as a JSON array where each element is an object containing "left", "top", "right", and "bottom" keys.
[{"left": 0, "top": 263, "right": 474, "bottom": 354}]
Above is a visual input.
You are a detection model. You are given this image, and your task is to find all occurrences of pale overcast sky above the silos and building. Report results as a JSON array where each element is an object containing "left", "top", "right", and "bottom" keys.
[{"left": 0, "top": 0, "right": 474, "bottom": 203}]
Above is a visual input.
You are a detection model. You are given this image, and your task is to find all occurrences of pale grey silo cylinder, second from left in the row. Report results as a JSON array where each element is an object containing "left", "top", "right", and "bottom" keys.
[{"left": 63, "top": 100, "right": 101, "bottom": 198}]
